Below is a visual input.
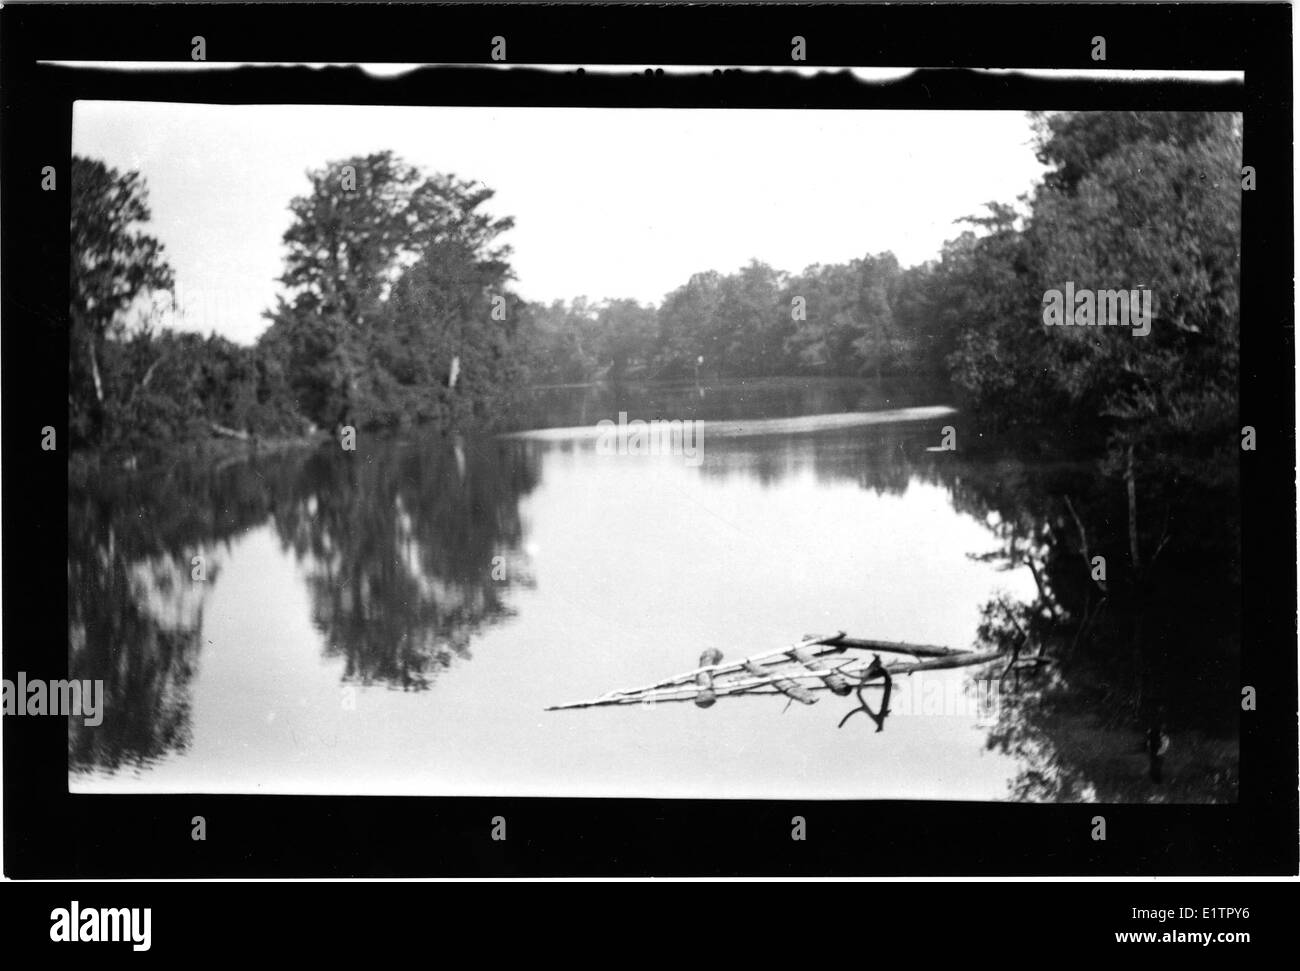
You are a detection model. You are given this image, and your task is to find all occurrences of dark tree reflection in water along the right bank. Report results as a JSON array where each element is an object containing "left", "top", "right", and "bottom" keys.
[{"left": 686, "top": 424, "right": 1240, "bottom": 802}]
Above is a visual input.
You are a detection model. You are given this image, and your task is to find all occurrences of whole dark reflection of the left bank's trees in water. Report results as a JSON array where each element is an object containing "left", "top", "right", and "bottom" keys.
[{"left": 68, "top": 437, "right": 538, "bottom": 770}]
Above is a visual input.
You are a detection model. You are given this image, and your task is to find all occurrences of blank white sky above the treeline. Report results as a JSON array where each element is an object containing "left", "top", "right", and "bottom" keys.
[{"left": 73, "top": 101, "right": 1041, "bottom": 343}]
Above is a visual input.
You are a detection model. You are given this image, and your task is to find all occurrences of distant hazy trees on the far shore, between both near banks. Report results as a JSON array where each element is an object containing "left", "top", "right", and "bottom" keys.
[{"left": 528, "top": 252, "right": 944, "bottom": 383}]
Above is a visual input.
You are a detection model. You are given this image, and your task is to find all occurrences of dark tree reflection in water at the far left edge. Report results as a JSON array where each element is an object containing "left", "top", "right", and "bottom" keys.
[{"left": 68, "top": 454, "right": 276, "bottom": 768}]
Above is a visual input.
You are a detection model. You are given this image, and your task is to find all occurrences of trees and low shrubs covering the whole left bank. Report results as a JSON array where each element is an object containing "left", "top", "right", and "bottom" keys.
[{"left": 69, "top": 152, "right": 525, "bottom": 448}]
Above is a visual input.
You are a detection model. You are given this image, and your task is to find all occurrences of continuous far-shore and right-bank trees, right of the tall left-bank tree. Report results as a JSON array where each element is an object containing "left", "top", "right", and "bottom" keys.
[{"left": 517, "top": 112, "right": 1240, "bottom": 428}]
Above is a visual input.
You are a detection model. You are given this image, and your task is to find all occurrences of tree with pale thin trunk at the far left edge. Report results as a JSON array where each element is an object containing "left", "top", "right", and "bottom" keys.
[{"left": 68, "top": 156, "right": 173, "bottom": 442}]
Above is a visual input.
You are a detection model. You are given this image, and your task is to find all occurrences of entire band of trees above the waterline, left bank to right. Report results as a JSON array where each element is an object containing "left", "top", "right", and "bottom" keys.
[{"left": 69, "top": 112, "right": 1242, "bottom": 462}]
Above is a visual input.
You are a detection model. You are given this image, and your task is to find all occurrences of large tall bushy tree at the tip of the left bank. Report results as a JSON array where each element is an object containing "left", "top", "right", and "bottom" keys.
[{"left": 264, "top": 152, "right": 517, "bottom": 426}]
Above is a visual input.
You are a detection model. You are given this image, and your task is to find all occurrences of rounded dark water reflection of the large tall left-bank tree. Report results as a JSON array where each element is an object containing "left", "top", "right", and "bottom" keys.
[{"left": 274, "top": 442, "right": 537, "bottom": 690}]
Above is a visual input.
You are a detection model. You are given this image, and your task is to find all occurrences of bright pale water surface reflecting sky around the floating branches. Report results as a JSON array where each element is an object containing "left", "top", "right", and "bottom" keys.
[{"left": 73, "top": 428, "right": 1032, "bottom": 799}]
